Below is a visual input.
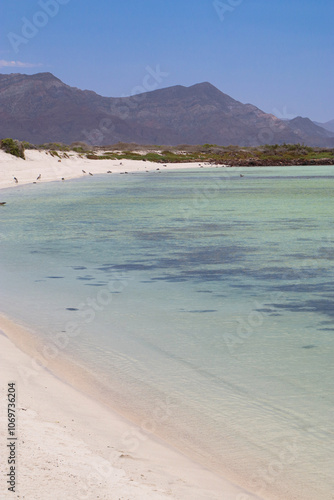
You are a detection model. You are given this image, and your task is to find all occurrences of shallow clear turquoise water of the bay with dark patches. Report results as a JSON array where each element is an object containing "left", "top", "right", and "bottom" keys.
[{"left": 0, "top": 167, "right": 334, "bottom": 500}]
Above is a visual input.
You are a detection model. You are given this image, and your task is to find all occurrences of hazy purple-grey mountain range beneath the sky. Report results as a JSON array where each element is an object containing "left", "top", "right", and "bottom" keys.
[{"left": 0, "top": 73, "right": 334, "bottom": 146}]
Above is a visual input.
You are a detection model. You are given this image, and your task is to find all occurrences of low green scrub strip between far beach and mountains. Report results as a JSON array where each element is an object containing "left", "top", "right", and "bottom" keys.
[{"left": 0, "top": 139, "right": 334, "bottom": 166}]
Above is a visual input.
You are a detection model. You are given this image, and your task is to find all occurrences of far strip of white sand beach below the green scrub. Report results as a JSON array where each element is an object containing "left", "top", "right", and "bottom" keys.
[{"left": 0, "top": 150, "right": 219, "bottom": 191}]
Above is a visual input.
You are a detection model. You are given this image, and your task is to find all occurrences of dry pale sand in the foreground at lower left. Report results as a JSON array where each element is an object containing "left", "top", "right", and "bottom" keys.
[{"left": 0, "top": 316, "right": 256, "bottom": 500}]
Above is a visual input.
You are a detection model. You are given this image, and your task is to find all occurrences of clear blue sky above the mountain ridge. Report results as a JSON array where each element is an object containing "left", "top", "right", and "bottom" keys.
[{"left": 0, "top": 0, "right": 334, "bottom": 122}]
